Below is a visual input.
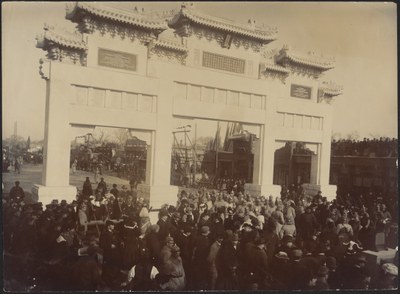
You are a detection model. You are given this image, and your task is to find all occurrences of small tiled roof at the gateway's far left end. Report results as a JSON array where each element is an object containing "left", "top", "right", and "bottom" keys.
[{"left": 36, "top": 24, "right": 87, "bottom": 50}]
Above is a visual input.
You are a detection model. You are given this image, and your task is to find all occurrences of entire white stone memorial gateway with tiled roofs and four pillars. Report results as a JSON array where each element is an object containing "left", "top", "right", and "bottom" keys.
[{"left": 32, "top": 2, "right": 342, "bottom": 208}]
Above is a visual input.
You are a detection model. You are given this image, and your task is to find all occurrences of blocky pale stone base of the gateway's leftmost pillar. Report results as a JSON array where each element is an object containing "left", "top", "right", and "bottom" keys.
[{"left": 32, "top": 184, "right": 77, "bottom": 205}]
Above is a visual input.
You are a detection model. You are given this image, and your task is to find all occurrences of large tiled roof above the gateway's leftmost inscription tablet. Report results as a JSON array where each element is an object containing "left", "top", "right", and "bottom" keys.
[{"left": 66, "top": 2, "right": 168, "bottom": 31}]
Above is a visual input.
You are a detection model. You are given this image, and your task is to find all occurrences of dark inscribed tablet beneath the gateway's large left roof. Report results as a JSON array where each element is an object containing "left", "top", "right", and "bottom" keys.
[{"left": 98, "top": 48, "right": 136, "bottom": 71}]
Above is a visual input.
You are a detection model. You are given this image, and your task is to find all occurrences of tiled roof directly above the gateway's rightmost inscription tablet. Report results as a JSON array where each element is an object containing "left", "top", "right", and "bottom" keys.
[{"left": 276, "top": 47, "right": 335, "bottom": 70}]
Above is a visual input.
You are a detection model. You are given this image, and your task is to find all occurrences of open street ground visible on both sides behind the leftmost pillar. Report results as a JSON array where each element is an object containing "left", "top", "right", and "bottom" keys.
[{"left": 2, "top": 164, "right": 129, "bottom": 203}]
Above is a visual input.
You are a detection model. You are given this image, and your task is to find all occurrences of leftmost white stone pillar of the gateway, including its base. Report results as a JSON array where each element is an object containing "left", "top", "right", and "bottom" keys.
[{"left": 32, "top": 63, "right": 77, "bottom": 204}]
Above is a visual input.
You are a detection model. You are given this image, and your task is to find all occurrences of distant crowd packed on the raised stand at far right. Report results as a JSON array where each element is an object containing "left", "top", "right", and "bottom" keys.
[{"left": 331, "top": 137, "right": 398, "bottom": 157}]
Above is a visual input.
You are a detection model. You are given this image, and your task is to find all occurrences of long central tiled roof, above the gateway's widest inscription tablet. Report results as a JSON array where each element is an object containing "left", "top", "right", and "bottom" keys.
[{"left": 168, "top": 7, "right": 277, "bottom": 42}]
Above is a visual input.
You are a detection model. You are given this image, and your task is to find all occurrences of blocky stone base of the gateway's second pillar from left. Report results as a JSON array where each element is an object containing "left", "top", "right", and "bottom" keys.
[{"left": 137, "top": 184, "right": 179, "bottom": 209}]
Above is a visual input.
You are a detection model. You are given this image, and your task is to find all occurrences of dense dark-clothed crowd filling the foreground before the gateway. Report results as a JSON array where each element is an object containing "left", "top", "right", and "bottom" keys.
[{"left": 3, "top": 178, "right": 398, "bottom": 291}]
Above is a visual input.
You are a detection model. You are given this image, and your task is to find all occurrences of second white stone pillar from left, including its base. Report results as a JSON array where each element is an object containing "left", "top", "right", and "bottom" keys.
[{"left": 138, "top": 80, "right": 178, "bottom": 209}]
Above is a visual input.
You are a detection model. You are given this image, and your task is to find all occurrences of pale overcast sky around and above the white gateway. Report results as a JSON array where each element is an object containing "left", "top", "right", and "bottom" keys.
[{"left": 2, "top": 2, "right": 398, "bottom": 140}]
